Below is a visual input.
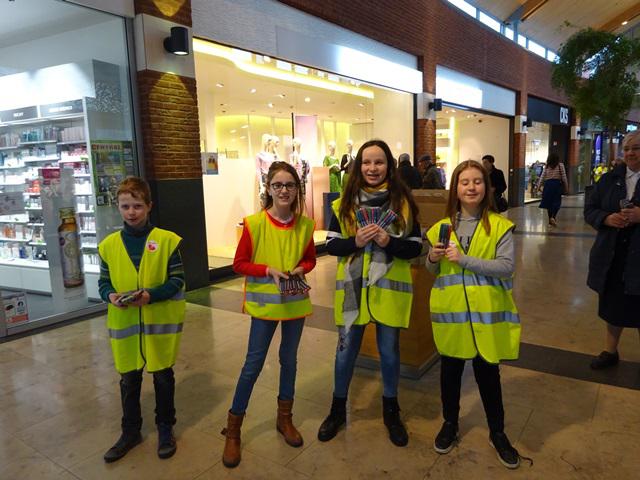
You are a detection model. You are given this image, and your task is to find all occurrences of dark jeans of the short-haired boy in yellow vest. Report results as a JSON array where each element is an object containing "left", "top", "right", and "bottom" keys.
[{"left": 120, "top": 368, "right": 176, "bottom": 433}]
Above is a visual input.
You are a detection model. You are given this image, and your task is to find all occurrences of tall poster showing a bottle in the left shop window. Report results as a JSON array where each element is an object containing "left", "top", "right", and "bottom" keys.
[{"left": 39, "top": 167, "right": 87, "bottom": 313}]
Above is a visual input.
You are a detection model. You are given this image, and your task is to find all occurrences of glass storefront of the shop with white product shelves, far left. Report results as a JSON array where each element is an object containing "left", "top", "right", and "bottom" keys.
[{"left": 0, "top": 0, "right": 137, "bottom": 336}]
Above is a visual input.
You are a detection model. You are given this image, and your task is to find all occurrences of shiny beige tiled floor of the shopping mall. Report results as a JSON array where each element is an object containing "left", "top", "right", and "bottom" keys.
[{"left": 0, "top": 198, "right": 640, "bottom": 480}]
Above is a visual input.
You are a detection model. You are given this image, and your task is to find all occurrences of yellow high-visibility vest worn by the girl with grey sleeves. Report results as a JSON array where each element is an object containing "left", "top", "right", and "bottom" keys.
[{"left": 427, "top": 212, "right": 520, "bottom": 363}]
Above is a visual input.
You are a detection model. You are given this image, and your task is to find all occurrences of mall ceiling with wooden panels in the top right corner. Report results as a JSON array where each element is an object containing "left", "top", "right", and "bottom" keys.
[{"left": 467, "top": 0, "right": 640, "bottom": 51}]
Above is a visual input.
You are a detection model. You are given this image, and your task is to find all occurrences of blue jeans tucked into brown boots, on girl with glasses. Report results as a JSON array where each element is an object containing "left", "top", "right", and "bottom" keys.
[{"left": 231, "top": 317, "right": 304, "bottom": 415}]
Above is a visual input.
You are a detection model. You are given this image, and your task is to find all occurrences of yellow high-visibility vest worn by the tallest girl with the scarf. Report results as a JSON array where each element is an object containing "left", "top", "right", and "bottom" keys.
[{"left": 331, "top": 199, "right": 413, "bottom": 328}]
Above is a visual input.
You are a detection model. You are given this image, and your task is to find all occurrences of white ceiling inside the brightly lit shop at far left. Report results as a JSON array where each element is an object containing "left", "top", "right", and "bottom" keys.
[{"left": 0, "top": 0, "right": 113, "bottom": 48}]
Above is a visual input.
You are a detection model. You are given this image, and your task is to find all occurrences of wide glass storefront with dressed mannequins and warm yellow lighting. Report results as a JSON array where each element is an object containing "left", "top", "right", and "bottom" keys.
[{"left": 194, "top": 39, "right": 414, "bottom": 268}]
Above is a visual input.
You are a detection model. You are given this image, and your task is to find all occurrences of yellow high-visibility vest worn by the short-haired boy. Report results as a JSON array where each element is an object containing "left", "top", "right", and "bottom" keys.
[{"left": 98, "top": 228, "right": 186, "bottom": 373}]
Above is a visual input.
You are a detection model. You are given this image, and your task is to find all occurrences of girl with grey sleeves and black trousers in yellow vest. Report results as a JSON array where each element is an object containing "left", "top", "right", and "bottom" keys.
[{"left": 427, "top": 160, "right": 524, "bottom": 468}]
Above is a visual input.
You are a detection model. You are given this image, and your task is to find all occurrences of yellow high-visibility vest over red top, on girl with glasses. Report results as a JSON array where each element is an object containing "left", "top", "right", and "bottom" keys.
[{"left": 243, "top": 210, "right": 315, "bottom": 320}]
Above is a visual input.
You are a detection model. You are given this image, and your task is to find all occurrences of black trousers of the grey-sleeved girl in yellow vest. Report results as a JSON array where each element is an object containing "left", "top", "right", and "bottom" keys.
[{"left": 440, "top": 356, "right": 504, "bottom": 432}]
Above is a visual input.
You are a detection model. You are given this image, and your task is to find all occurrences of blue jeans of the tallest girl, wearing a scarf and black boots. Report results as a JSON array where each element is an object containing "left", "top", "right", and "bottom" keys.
[{"left": 333, "top": 323, "right": 400, "bottom": 398}]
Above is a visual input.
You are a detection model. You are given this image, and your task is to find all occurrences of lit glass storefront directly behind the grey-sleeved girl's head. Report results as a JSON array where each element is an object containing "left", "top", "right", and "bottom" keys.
[{"left": 436, "top": 105, "right": 509, "bottom": 190}]
